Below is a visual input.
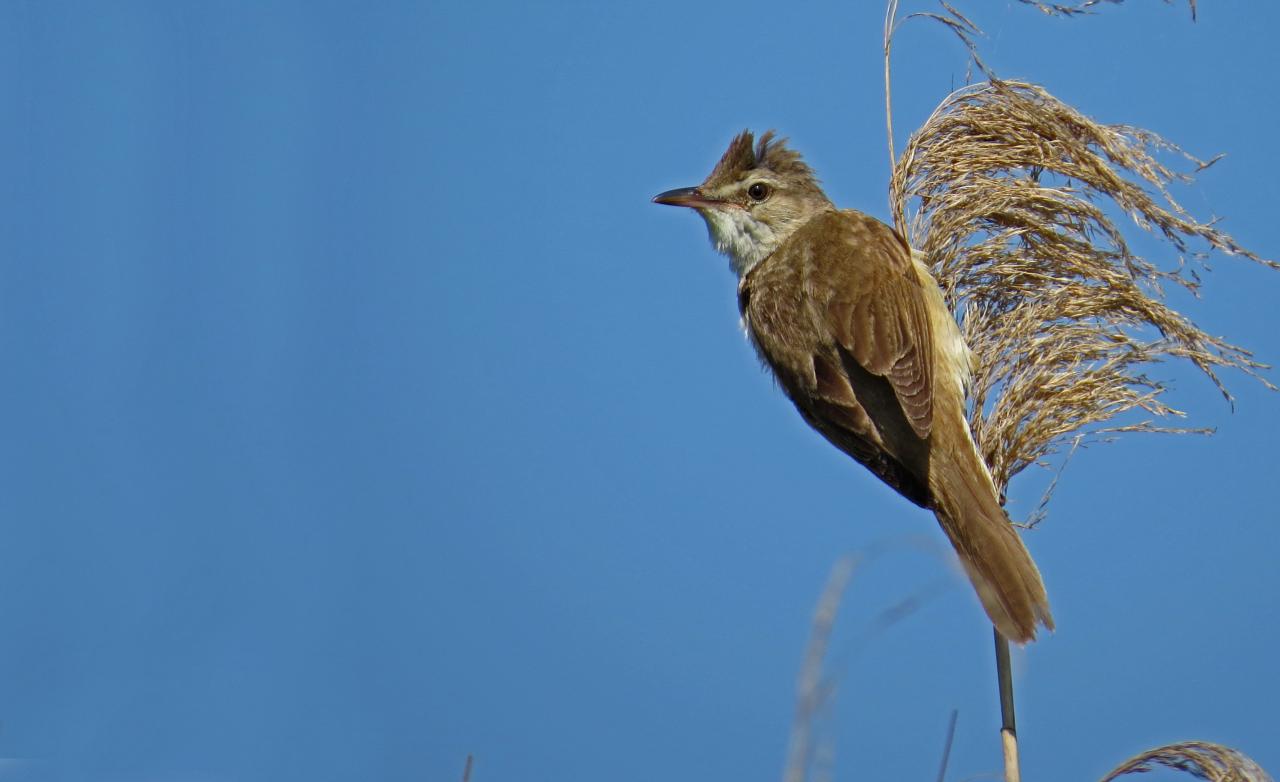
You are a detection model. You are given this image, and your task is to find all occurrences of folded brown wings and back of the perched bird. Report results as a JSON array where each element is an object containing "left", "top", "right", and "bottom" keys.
[{"left": 742, "top": 211, "right": 933, "bottom": 504}]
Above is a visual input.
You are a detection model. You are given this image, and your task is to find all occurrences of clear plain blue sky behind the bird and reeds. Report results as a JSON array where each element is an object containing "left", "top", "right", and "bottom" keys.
[{"left": 0, "top": 0, "right": 1280, "bottom": 782}]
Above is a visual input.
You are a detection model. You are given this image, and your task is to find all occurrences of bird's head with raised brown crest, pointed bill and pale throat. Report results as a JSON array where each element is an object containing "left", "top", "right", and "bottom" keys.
[{"left": 653, "top": 131, "right": 835, "bottom": 276}]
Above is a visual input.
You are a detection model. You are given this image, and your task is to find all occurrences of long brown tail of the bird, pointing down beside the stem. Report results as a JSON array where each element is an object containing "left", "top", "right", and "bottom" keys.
[{"left": 929, "top": 440, "right": 1053, "bottom": 644}]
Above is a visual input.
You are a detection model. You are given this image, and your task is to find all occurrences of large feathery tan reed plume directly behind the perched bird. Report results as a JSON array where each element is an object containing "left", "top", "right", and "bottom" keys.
[{"left": 890, "top": 76, "right": 1280, "bottom": 490}]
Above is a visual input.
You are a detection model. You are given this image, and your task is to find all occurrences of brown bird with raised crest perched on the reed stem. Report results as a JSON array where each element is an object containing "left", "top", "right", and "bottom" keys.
[{"left": 653, "top": 131, "right": 1053, "bottom": 644}]
